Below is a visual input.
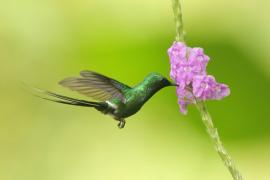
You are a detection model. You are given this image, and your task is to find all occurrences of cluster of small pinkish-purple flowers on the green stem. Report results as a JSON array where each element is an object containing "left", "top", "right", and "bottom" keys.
[{"left": 168, "top": 42, "right": 230, "bottom": 114}]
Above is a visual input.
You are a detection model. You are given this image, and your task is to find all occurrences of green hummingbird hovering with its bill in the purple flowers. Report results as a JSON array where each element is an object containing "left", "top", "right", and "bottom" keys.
[{"left": 38, "top": 70, "right": 177, "bottom": 129}]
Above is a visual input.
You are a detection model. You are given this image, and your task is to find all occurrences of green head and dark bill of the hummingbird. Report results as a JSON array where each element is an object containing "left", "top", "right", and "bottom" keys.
[{"left": 145, "top": 73, "right": 177, "bottom": 88}]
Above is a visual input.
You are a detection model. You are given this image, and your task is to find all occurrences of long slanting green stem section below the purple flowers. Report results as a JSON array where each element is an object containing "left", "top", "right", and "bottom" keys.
[{"left": 196, "top": 101, "right": 243, "bottom": 180}]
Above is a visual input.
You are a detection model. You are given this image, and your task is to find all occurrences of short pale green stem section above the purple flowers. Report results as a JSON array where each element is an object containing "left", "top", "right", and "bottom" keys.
[{"left": 172, "top": 0, "right": 185, "bottom": 42}]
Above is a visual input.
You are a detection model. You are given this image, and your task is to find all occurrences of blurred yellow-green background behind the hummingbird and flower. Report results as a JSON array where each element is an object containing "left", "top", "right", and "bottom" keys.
[{"left": 0, "top": 0, "right": 270, "bottom": 180}]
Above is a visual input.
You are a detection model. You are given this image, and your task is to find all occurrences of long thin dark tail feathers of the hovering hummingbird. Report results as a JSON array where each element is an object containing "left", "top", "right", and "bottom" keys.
[{"left": 26, "top": 88, "right": 108, "bottom": 111}]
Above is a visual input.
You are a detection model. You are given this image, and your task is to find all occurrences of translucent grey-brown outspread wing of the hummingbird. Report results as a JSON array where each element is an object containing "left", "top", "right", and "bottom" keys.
[{"left": 59, "top": 70, "right": 130, "bottom": 103}]
